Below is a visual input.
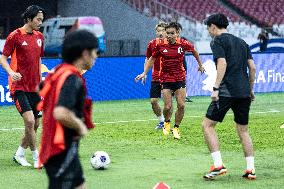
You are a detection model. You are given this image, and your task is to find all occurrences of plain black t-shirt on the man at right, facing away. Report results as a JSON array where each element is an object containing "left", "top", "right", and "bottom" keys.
[{"left": 210, "top": 33, "right": 252, "bottom": 98}]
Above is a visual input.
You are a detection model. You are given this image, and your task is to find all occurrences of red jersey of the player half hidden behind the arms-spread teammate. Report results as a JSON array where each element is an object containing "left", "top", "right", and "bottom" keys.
[{"left": 146, "top": 38, "right": 161, "bottom": 81}]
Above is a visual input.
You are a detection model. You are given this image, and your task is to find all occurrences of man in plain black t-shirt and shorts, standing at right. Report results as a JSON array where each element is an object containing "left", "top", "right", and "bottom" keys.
[{"left": 202, "top": 14, "right": 256, "bottom": 180}]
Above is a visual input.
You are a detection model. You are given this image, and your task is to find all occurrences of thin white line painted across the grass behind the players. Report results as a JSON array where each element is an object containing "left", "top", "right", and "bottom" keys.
[{"left": 0, "top": 109, "right": 284, "bottom": 132}]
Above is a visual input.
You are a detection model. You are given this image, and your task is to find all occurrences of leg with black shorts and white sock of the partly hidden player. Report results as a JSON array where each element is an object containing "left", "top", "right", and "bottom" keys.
[{"left": 150, "top": 82, "right": 165, "bottom": 129}]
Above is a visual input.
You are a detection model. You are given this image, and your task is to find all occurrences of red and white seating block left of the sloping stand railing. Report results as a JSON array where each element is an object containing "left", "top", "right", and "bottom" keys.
[{"left": 122, "top": 0, "right": 266, "bottom": 41}]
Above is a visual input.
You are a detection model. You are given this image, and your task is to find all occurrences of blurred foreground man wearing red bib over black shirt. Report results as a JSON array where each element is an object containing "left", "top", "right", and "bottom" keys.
[{"left": 38, "top": 30, "right": 98, "bottom": 189}]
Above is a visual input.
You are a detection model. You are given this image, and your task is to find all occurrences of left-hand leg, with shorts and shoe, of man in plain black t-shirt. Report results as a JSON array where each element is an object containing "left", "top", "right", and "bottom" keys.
[{"left": 202, "top": 97, "right": 231, "bottom": 180}]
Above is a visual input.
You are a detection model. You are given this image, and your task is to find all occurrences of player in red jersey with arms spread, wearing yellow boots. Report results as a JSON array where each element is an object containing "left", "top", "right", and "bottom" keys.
[{"left": 135, "top": 22, "right": 205, "bottom": 139}]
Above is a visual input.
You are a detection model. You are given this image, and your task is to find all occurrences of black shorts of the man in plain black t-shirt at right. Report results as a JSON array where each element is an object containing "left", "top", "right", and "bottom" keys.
[{"left": 206, "top": 96, "right": 251, "bottom": 125}]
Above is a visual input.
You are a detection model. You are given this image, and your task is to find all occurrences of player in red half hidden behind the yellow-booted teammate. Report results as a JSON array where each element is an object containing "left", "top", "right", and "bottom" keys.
[{"left": 142, "top": 23, "right": 166, "bottom": 129}]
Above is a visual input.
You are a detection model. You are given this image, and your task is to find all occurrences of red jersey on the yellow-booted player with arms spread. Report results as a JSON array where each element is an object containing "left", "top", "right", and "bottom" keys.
[{"left": 152, "top": 38, "right": 194, "bottom": 83}]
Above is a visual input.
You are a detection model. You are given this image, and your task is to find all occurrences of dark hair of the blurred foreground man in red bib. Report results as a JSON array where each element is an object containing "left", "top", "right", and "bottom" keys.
[{"left": 62, "top": 30, "right": 98, "bottom": 64}]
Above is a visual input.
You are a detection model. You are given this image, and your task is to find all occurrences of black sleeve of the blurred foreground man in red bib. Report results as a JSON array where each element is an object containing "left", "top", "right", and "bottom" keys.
[{"left": 57, "top": 75, "right": 83, "bottom": 110}]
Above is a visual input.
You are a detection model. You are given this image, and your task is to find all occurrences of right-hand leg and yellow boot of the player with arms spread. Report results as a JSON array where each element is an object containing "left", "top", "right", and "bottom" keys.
[{"left": 173, "top": 87, "right": 186, "bottom": 139}]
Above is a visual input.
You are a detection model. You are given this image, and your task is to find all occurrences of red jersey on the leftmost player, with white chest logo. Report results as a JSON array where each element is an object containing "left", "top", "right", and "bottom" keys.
[{"left": 3, "top": 28, "right": 44, "bottom": 95}]
